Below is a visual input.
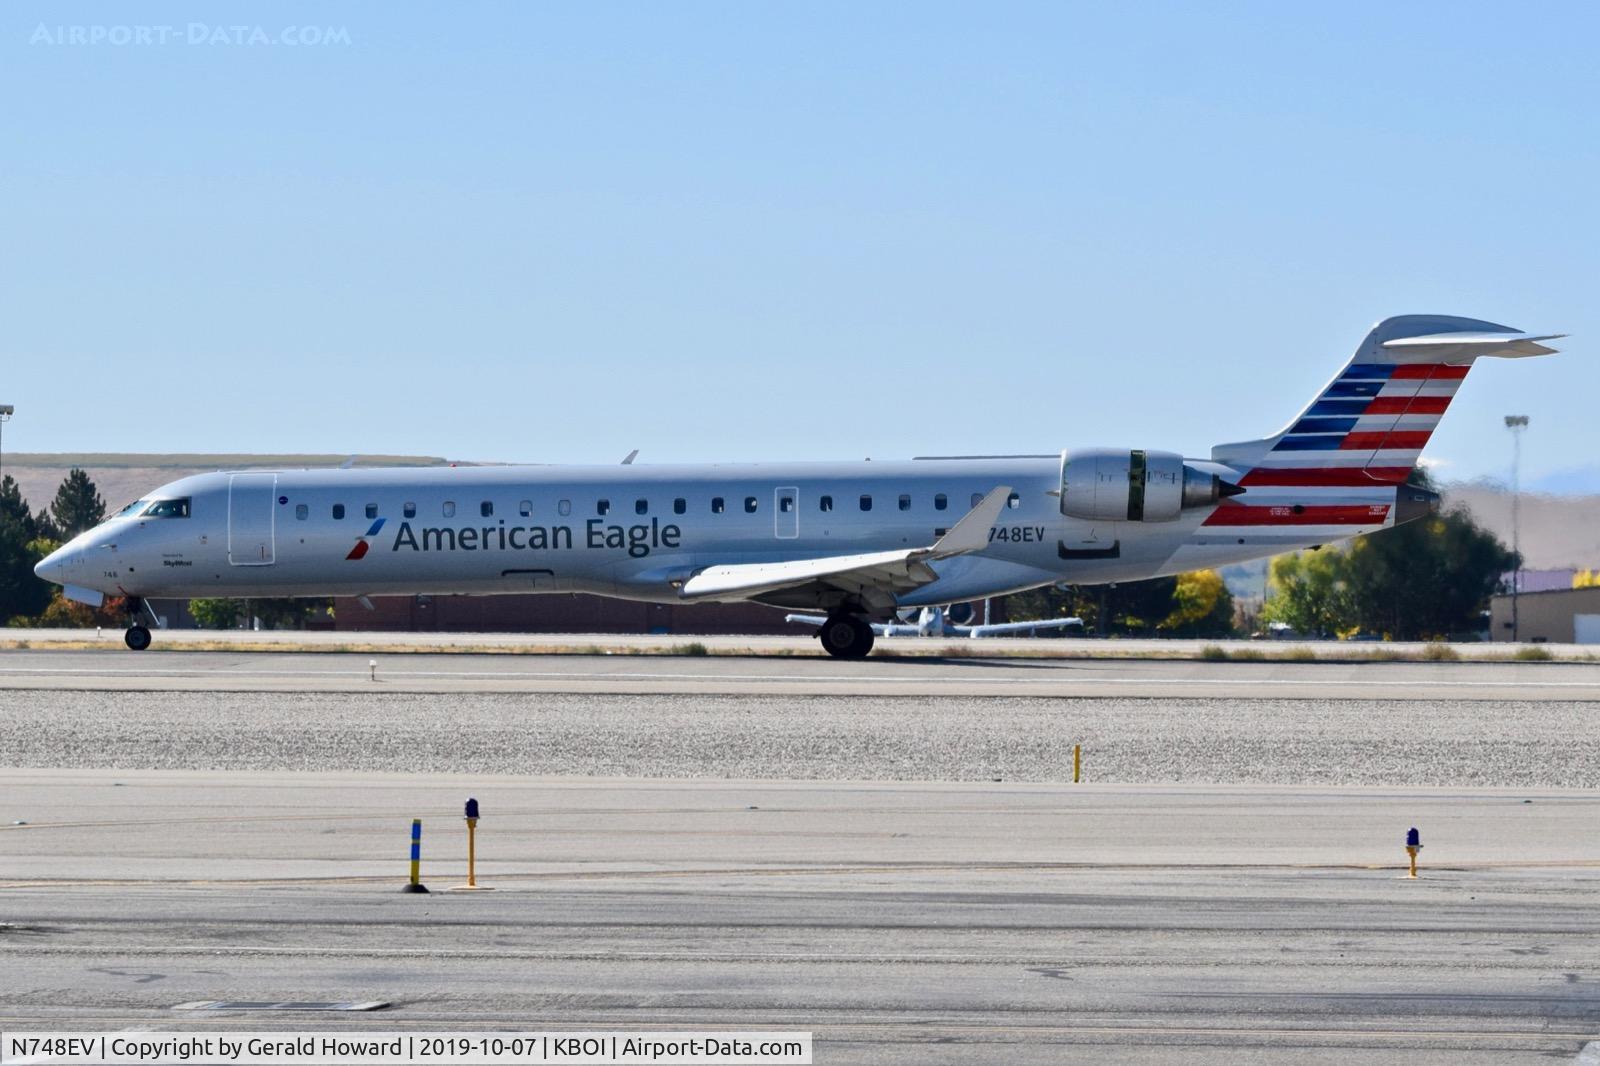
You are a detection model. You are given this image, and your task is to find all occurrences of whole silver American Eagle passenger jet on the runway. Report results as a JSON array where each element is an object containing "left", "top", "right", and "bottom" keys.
[{"left": 35, "top": 315, "right": 1565, "bottom": 658}]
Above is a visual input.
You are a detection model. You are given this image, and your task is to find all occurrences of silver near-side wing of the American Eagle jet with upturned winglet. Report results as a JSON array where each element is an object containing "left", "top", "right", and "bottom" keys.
[{"left": 678, "top": 485, "right": 1011, "bottom": 600}]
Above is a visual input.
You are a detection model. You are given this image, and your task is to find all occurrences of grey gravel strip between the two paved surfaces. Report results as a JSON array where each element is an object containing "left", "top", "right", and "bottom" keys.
[{"left": 0, "top": 691, "right": 1600, "bottom": 787}]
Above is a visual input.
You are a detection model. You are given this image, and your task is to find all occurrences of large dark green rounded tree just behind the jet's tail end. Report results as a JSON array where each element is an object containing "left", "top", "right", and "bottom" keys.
[{"left": 1346, "top": 507, "right": 1517, "bottom": 640}]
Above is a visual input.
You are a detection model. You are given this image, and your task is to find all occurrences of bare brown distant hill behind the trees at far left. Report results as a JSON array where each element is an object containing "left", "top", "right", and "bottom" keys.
[{"left": 3, "top": 451, "right": 450, "bottom": 512}]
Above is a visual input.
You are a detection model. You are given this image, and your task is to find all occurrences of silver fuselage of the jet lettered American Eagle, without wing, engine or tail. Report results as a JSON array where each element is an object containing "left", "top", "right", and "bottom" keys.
[{"left": 40, "top": 456, "right": 1337, "bottom": 608}]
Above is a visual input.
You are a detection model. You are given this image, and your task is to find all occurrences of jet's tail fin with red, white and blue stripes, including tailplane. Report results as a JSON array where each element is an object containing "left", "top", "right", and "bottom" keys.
[{"left": 1198, "top": 315, "right": 1560, "bottom": 547}]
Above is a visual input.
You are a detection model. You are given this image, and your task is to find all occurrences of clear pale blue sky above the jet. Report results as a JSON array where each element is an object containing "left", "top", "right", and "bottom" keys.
[{"left": 0, "top": 3, "right": 1600, "bottom": 479}]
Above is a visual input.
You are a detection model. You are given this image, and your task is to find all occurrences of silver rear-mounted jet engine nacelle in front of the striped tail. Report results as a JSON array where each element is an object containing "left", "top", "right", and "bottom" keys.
[{"left": 1061, "top": 448, "right": 1245, "bottom": 522}]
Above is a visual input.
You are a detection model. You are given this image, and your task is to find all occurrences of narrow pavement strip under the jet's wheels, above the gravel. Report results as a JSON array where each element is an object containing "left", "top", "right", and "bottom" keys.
[{"left": 0, "top": 647, "right": 1600, "bottom": 701}]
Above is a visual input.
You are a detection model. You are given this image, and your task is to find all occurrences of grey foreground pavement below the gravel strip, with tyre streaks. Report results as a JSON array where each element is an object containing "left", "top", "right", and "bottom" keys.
[{"left": 0, "top": 770, "right": 1600, "bottom": 1063}]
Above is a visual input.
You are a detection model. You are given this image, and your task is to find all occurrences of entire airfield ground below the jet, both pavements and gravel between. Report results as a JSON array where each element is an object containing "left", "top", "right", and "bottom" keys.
[{"left": 0, "top": 648, "right": 1600, "bottom": 1064}]
